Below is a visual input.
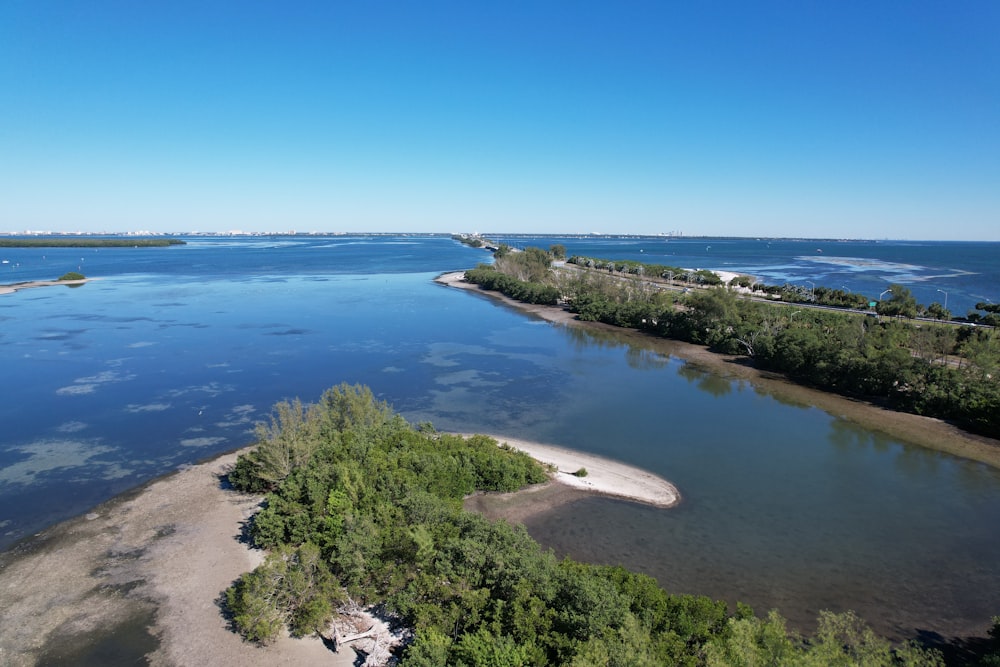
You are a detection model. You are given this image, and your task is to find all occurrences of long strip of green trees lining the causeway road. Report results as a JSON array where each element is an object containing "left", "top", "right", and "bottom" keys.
[{"left": 465, "top": 246, "right": 1000, "bottom": 438}]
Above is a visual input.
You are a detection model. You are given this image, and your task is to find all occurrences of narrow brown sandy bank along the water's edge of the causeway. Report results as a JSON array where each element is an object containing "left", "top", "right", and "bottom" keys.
[{"left": 434, "top": 271, "right": 1000, "bottom": 469}]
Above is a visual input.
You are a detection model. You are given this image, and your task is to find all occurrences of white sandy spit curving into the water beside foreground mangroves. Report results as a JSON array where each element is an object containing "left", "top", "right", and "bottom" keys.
[{"left": 455, "top": 433, "right": 681, "bottom": 511}]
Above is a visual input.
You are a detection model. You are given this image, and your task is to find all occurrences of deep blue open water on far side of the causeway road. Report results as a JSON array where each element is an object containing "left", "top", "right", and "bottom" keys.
[{"left": 487, "top": 235, "right": 1000, "bottom": 316}]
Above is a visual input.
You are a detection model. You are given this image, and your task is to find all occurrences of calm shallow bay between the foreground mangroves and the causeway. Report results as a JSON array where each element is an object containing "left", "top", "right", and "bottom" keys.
[{"left": 0, "top": 237, "right": 1000, "bottom": 636}]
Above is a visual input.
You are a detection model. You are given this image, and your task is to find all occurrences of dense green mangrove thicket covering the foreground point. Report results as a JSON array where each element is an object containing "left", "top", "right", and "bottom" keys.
[{"left": 225, "top": 385, "right": 964, "bottom": 667}]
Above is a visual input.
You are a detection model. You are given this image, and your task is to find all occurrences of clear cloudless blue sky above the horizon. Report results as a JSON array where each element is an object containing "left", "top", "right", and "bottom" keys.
[{"left": 0, "top": 0, "right": 1000, "bottom": 240}]
